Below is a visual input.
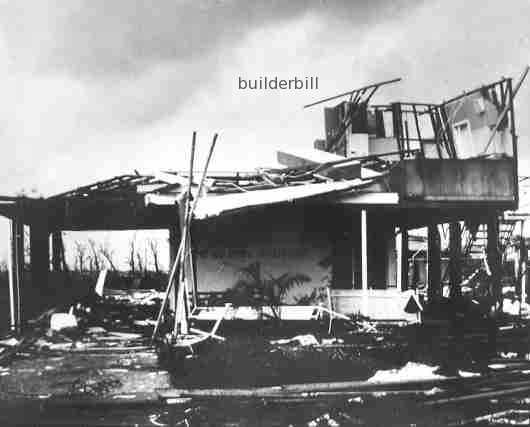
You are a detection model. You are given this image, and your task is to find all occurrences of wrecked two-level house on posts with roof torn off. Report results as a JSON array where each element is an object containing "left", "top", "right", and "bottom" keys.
[{"left": 0, "top": 75, "right": 518, "bottom": 323}]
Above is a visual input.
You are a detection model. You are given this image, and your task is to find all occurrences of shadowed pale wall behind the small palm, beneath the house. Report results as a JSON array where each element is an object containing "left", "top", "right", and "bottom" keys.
[{"left": 194, "top": 208, "right": 331, "bottom": 303}]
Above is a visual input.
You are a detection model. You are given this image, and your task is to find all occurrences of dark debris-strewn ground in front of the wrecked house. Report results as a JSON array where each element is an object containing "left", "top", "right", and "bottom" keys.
[{"left": 0, "top": 294, "right": 530, "bottom": 427}]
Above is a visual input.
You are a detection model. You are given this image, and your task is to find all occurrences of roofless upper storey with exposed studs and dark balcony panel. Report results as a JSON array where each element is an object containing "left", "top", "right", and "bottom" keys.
[{"left": 315, "top": 79, "right": 518, "bottom": 207}]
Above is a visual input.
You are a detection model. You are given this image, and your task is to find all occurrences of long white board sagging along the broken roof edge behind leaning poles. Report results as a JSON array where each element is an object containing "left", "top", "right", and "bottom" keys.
[{"left": 145, "top": 179, "right": 367, "bottom": 219}]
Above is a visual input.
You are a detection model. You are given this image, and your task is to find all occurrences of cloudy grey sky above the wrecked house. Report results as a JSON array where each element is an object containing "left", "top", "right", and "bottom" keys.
[{"left": 0, "top": 0, "right": 530, "bottom": 268}]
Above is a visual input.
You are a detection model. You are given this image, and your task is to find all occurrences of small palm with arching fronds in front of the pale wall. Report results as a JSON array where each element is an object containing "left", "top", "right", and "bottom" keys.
[{"left": 226, "top": 261, "right": 311, "bottom": 320}]
